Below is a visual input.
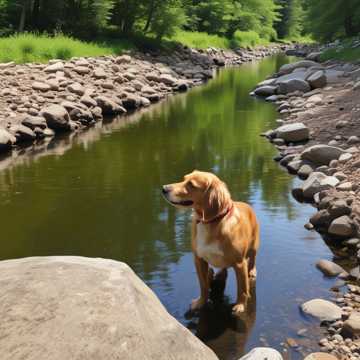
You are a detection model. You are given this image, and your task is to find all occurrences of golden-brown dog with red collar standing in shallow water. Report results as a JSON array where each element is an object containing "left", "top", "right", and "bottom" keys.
[{"left": 163, "top": 171, "right": 259, "bottom": 314}]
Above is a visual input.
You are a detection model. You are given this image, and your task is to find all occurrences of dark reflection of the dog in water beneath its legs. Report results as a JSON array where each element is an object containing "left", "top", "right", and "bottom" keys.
[{"left": 185, "top": 270, "right": 256, "bottom": 354}]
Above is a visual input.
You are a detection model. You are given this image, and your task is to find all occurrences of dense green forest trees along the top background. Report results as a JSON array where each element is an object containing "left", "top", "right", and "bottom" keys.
[{"left": 0, "top": 0, "right": 360, "bottom": 44}]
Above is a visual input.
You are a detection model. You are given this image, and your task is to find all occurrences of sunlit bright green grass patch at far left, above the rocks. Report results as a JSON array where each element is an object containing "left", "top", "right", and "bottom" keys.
[{"left": 0, "top": 33, "right": 132, "bottom": 64}]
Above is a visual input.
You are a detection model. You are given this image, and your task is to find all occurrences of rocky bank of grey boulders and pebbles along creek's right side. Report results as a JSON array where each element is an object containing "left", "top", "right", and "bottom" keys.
[{"left": 252, "top": 41, "right": 360, "bottom": 360}]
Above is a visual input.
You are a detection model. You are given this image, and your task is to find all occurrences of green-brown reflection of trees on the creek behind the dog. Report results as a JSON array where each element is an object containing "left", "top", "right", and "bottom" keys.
[{"left": 0, "top": 54, "right": 293, "bottom": 279}]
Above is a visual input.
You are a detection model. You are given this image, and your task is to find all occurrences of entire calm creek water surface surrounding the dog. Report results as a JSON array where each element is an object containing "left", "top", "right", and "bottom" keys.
[{"left": 0, "top": 55, "right": 340, "bottom": 359}]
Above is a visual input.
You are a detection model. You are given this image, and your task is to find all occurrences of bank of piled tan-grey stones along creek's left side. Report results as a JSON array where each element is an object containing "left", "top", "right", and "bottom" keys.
[{"left": 0, "top": 45, "right": 286, "bottom": 152}]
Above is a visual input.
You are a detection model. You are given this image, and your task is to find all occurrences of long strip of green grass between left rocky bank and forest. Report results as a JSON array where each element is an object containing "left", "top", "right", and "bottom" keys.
[{"left": 0, "top": 31, "right": 276, "bottom": 64}]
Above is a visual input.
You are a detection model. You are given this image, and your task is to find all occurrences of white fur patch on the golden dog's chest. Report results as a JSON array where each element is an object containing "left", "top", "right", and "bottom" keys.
[{"left": 196, "top": 223, "right": 226, "bottom": 268}]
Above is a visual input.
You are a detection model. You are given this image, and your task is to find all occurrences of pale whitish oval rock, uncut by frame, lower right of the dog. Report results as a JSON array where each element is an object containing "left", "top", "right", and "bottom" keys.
[{"left": 301, "top": 299, "right": 342, "bottom": 321}]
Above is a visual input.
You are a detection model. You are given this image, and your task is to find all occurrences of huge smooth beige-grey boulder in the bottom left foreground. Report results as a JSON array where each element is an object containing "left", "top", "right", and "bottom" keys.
[{"left": 0, "top": 257, "right": 217, "bottom": 360}]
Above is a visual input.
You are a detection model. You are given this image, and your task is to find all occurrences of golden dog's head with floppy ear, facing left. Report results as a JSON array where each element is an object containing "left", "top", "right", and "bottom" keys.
[{"left": 162, "top": 170, "right": 231, "bottom": 218}]
